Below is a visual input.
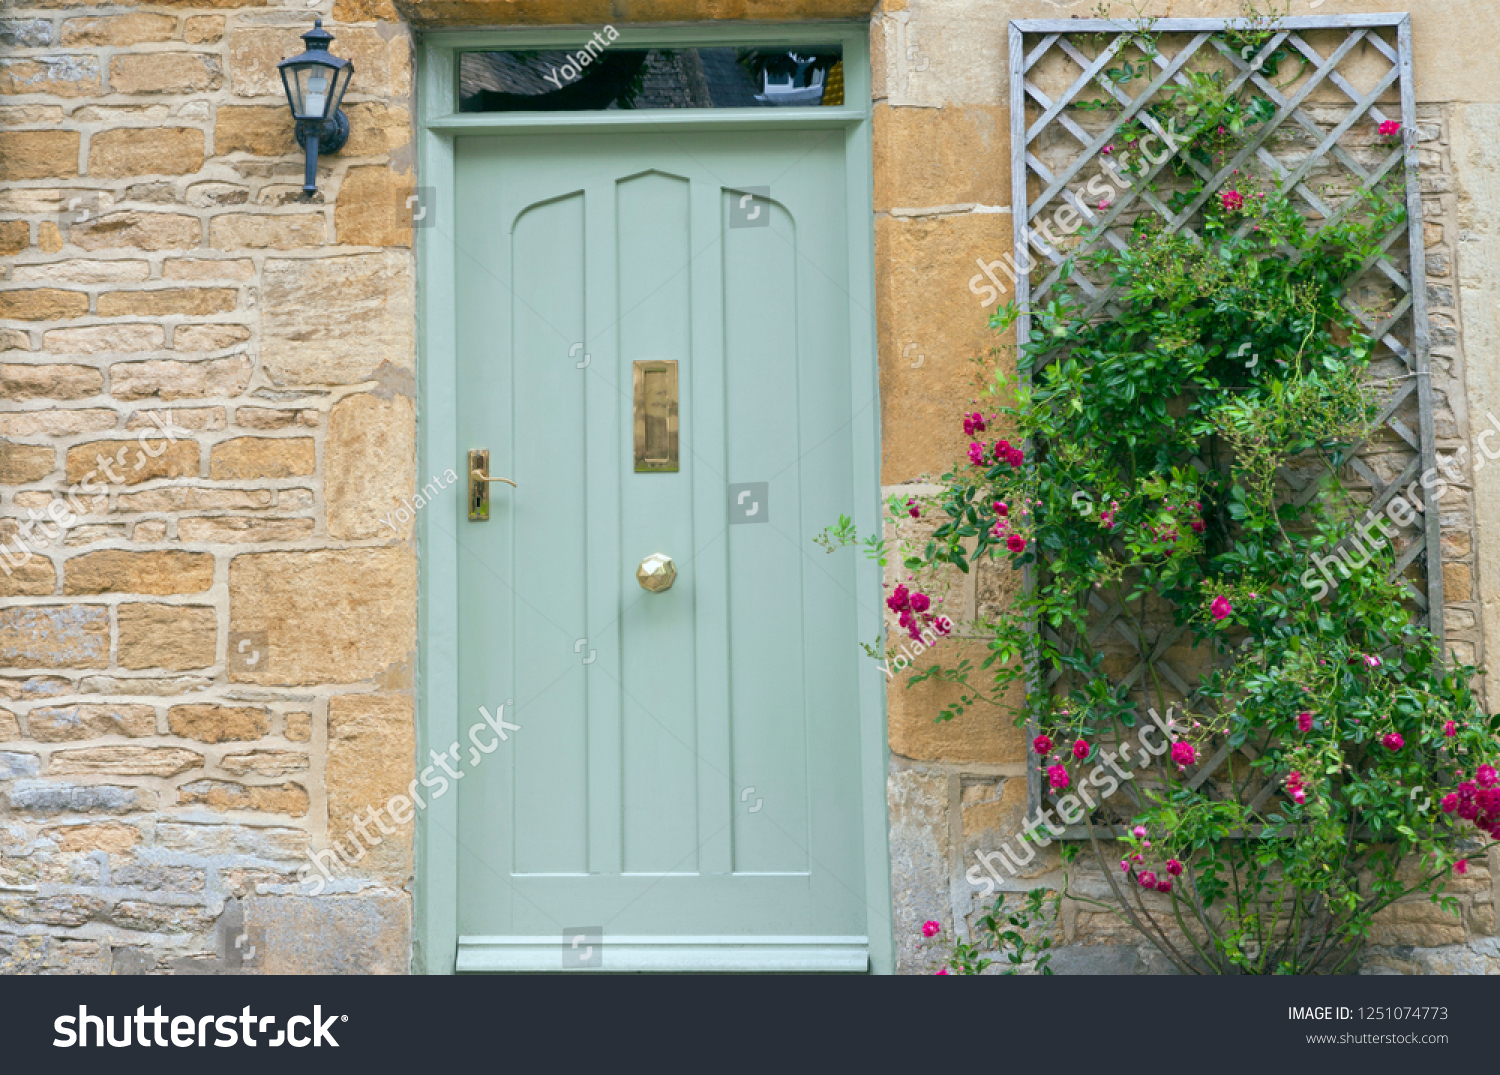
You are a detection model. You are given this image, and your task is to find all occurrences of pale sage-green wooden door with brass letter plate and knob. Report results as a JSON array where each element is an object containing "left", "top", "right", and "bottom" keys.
[{"left": 456, "top": 130, "right": 884, "bottom": 970}]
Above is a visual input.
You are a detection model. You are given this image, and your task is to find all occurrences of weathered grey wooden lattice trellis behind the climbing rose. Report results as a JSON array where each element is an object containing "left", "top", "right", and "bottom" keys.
[{"left": 1010, "top": 15, "right": 1443, "bottom": 837}]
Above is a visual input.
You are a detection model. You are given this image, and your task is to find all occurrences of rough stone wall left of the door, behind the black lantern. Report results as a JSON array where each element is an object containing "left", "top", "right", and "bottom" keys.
[{"left": 0, "top": 0, "right": 417, "bottom": 972}]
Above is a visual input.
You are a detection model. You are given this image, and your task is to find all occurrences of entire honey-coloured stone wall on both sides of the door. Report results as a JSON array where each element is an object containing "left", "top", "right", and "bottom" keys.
[{"left": 0, "top": 0, "right": 1500, "bottom": 973}]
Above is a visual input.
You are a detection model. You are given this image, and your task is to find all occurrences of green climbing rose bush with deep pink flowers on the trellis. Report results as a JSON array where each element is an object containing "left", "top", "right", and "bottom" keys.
[{"left": 836, "top": 35, "right": 1500, "bottom": 973}]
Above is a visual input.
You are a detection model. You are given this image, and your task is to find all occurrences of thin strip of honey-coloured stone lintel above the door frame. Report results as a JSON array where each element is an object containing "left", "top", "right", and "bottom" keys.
[{"left": 395, "top": 0, "right": 876, "bottom": 30}]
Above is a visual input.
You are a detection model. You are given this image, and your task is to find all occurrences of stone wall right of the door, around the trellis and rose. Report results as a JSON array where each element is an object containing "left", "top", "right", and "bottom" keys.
[{"left": 872, "top": 0, "right": 1500, "bottom": 973}]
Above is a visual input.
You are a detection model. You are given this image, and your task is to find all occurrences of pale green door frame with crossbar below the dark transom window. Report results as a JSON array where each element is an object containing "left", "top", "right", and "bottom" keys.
[{"left": 413, "top": 21, "right": 896, "bottom": 975}]
